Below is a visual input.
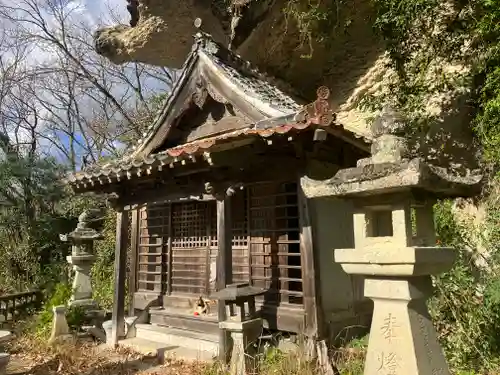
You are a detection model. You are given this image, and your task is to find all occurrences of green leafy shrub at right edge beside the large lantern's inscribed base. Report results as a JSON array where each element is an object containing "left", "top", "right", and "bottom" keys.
[{"left": 429, "top": 201, "right": 500, "bottom": 371}]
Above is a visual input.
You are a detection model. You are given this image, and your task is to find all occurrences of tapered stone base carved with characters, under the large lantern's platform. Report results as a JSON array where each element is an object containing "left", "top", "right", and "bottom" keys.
[{"left": 364, "top": 276, "right": 450, "bottom": 375}]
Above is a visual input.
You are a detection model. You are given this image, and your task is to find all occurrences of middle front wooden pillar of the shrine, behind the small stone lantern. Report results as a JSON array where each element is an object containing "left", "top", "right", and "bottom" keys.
[{"left": 216, "top": 194, "right": 233, "bottom": 363}]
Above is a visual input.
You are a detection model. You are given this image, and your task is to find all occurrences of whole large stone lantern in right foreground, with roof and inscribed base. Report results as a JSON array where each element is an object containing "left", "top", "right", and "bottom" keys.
[{"left": 302, "top": 109, "right": 482, "bottom": 375}]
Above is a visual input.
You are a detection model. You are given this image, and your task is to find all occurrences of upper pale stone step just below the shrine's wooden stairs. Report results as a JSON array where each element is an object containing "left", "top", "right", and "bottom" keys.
[{"left": 136, "top": 324, "right": 219, "bottom": 357}]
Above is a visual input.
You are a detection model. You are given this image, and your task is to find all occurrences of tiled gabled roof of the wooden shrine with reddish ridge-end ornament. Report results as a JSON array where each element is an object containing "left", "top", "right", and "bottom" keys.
[{"left": 66, "top": 33, "right": 370, "bottom": 191}]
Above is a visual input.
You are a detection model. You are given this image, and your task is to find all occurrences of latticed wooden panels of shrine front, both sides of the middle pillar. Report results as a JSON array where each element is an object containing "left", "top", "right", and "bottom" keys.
[{"left": 138, "top": 182, "right": 302, "bottom": 305}]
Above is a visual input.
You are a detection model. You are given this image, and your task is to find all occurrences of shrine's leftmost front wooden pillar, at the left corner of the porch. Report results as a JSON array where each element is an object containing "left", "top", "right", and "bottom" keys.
[{"left": 110, "top": 207, "right": 128, "bottom": 347}]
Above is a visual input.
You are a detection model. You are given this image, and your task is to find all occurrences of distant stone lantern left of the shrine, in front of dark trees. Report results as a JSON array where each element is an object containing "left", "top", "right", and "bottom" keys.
[{"left": 60, "top": 211, "right": 103, "bottom": 308}]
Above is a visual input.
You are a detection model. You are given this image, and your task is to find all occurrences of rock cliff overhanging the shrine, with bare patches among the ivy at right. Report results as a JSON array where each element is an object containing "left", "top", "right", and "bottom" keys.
[{"left": 95, "top": 0, "right": 477, "bottom": 178}]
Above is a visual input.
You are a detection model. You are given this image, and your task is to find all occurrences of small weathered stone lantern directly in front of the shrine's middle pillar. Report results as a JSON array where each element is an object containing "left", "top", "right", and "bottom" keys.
[{"left": 212, "top": 284, "right": 265, "bottom": 375}]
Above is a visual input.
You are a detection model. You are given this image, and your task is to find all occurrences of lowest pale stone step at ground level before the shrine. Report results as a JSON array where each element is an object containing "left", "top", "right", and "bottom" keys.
[{"left": 119, "top": 337, "right": 213, "bottom": 362}]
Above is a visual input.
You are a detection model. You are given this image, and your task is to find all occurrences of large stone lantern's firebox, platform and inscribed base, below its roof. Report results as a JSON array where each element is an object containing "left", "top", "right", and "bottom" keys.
[{"left": 335, "top": 198, "right": 456, "bottom": 375}]
